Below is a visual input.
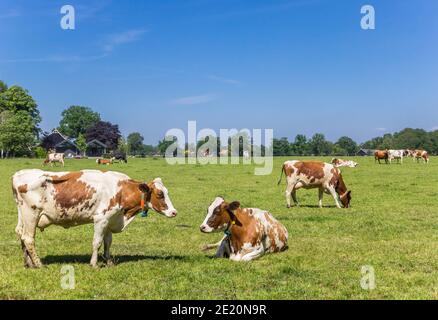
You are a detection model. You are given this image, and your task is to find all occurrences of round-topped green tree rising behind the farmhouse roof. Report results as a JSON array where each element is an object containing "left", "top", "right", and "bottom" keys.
[{"left": 59, "top": 106, "right": 100, "bottom": 138}]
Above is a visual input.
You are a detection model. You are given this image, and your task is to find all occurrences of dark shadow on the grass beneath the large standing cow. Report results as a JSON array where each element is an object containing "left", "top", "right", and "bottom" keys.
[{"left": 42, "top": 254, "right": 188, "bottom": 265}]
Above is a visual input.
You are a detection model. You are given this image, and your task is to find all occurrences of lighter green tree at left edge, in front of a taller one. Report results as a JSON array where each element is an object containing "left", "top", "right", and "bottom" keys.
[{"left": 0, "top": 111, "right": 36, "bottom": 157}]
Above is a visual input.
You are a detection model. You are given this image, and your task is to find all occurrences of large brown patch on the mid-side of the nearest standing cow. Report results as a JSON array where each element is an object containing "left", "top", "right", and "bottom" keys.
[{"left": 51, "top": 171, "right": 96, "bottom": 214}]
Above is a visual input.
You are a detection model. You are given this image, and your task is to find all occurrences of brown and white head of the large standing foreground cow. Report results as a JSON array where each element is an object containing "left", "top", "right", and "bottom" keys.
[{"left": 139, "top": 178, "right": 178, "bottom": 218}]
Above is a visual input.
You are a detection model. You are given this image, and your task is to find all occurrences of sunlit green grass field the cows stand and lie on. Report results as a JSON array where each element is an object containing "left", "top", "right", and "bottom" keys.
[{"left": 0, "top": 158, "right": 438, "bottom": 299}]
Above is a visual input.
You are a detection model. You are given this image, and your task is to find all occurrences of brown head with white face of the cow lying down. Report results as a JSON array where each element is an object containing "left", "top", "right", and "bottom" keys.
[{"left": 199, "top": 197, "right": 240, "bottom": 233}]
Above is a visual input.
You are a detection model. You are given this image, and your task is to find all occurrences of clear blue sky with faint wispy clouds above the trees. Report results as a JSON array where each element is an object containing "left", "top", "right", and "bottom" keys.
[{"left": 0, "top": 0, "right": 438, "bottom": 143}]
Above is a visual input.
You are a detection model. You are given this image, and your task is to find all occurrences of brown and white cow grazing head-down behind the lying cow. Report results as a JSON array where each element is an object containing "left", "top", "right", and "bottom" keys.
[{"left": 278, "top": 160, "right": 351, "bottom": 208}]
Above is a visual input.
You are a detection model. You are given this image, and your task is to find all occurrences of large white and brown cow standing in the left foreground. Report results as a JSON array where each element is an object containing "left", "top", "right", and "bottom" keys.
[{"left": 12, "top": 169, "right": 177, "bottom": 268}]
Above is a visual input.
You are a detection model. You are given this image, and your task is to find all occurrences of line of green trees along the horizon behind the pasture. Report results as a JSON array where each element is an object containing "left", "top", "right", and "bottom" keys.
[{"left": 0, "top": 81, "right": 438, "bottom": 158}]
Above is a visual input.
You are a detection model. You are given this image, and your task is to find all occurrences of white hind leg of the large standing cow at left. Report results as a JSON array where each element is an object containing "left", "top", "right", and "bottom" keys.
[{"left": 21, "top": 208, "right": 42, "bottom": 268}]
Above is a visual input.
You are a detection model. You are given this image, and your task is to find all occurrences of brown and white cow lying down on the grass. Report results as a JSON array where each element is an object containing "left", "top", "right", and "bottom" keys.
[{"left": 200, "top": 197, "right": 288, "bottom": 261}]
